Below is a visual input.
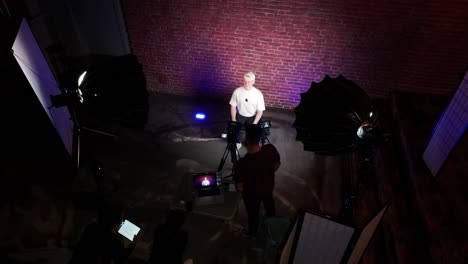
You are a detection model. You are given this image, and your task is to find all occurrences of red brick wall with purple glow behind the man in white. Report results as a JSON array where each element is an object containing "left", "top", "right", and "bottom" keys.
[{"left": 123, "top": 0, "right": 468, "bottom": 108}]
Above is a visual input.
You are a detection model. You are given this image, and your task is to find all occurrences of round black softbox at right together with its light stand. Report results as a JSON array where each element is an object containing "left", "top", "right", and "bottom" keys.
[{"left": 293, "top": 75, "right": 392, "bottom": 225}]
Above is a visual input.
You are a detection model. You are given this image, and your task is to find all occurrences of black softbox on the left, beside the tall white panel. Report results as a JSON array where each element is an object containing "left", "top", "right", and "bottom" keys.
[{"left": 79, "top": 54, "right": 149, "bottom": 129}]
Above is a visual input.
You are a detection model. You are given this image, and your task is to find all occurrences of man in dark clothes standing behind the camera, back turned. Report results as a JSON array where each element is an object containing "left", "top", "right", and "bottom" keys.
[{"left": 234, "top": 124, "right": 280, "bottom": 237}]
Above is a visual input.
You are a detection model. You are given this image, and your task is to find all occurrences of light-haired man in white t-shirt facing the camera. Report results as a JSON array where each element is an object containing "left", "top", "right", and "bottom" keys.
[{"left": 229, "top": 72, "right": 265, "bottom": 126}]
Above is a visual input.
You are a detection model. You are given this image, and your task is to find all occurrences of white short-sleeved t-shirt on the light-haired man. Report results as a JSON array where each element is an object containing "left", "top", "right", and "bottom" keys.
[{"left": 229, "top": 86, "right": 265, "bottom": 117}]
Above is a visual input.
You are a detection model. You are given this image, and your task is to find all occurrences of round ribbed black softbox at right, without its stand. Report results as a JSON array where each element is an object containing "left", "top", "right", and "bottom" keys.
[{"left": 294, "top": 75, "right": 376, "bottom": 155}]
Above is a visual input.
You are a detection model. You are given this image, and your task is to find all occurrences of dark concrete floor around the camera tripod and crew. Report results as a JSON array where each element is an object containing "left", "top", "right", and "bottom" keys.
[{"left": 0, "top": 94, "right": 358, "bottom": 263}]
